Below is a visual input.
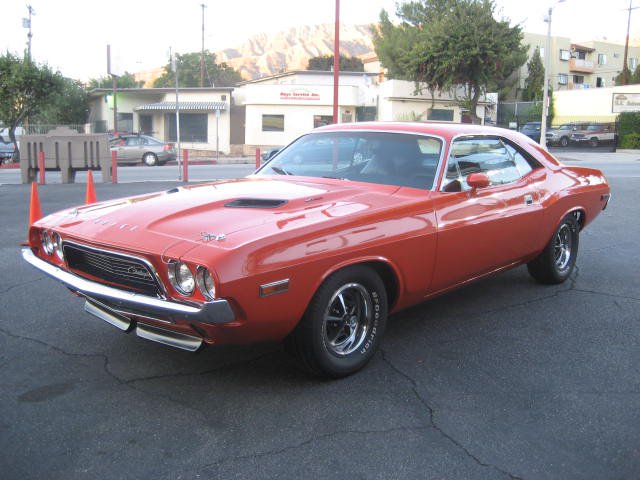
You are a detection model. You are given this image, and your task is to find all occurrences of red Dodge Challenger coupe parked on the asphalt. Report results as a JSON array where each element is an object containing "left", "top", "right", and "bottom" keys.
[{"left": 22, "top": 123, "right": 610, "bottom": 378}]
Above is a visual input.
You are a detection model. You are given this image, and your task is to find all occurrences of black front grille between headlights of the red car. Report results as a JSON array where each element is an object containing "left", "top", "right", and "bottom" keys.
[{"left": 62, "top": 242, "right": 162, "bottom": 296}]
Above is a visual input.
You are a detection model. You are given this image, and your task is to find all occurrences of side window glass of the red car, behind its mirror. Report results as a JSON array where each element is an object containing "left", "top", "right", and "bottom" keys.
[{"left": 441, "top": 137, "right": 533, "bottom": 192}]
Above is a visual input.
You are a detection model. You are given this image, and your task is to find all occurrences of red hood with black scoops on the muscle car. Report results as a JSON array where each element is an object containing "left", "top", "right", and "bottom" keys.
[{"left": 40, "top": 177, "right": 399, "bottom": 255}]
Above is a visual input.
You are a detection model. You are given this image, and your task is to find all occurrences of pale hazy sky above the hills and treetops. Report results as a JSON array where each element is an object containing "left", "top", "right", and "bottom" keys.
[{"left": 0, "top": 0, "right": 640, "bottom": 80}]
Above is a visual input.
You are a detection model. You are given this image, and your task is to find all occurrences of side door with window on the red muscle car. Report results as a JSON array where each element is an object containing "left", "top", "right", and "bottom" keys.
[{"left": 432, "top": 136, "right": 543, "bottom": 292}]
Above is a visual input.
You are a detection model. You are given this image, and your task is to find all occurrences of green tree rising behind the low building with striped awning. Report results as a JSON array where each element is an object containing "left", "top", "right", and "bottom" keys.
[{"left": 153, "top": 50, "right": 242, "bottom": 87}]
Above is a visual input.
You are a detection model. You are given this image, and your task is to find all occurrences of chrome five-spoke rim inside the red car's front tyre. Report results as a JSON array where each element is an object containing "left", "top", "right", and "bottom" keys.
[{"left": 322, "top": 283, "right": 373, "bottom": 356}]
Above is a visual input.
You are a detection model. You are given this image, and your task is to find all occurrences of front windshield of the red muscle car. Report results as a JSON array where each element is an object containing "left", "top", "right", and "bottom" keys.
[{"left": 256, "top": 132, "right": 442, "bottom": 190}]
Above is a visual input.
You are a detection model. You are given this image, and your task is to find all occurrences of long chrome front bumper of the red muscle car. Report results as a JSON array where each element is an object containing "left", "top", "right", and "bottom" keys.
[{"left": 22, "top": 247, "right": 235, "bottom": 325}]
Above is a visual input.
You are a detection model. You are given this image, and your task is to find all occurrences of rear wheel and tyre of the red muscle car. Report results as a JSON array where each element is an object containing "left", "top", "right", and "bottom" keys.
[{"left": 527, "top": 214, "right": 580, "bottom": 284}]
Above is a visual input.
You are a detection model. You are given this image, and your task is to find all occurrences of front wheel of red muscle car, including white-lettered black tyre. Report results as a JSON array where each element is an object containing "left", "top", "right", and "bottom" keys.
[{"left": 285, "top": 266, "right": 387, "bottom": 378}]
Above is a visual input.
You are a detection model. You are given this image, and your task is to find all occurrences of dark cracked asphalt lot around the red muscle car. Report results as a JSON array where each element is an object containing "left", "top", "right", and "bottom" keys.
[{"left": 0, "top": 158, "right": 640, "bottom": 480}]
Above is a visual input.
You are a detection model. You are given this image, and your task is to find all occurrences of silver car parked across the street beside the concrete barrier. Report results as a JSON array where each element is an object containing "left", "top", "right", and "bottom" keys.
[{"left": 110, "top": 135, "right": 176, "bottom": 167}]
